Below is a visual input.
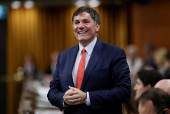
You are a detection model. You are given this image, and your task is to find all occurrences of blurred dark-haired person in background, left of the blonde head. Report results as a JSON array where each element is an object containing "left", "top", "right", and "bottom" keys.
[{"left": 143, "top": 43, "right": 157, "bottom": 70}]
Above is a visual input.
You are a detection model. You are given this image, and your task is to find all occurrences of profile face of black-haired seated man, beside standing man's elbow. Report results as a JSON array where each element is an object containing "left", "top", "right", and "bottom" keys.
[{"left": 134, "top": 78, "right": 148, "bottom": 100}]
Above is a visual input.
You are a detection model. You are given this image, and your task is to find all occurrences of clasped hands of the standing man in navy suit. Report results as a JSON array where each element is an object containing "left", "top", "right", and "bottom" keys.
[{"left": 64, "top": 86, "right": 86, "bottom": 105}]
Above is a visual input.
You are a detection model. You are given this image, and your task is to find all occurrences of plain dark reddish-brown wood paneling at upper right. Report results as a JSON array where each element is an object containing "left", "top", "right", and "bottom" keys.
[{"left": 130, "top": 0, "right": 170, "bottom": 54}]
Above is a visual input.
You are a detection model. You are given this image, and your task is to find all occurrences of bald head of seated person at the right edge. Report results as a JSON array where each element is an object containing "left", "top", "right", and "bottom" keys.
[{"left": 155, "top": 79, "right": 170, "bottom": 95}]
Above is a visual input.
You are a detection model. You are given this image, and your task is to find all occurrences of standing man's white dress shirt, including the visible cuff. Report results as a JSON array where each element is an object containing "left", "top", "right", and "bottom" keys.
[{"left": 72, "top": 37, "right": 97, "bottom": 106}]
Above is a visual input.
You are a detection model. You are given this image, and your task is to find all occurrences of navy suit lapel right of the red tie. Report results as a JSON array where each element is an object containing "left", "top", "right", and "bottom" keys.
[{"left": 80, "top": 39, "right": 103, "bottom": 90}]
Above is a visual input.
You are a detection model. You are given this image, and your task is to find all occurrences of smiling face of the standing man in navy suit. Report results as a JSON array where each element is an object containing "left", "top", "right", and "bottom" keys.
[{"left": 73, "top": 12, "right": 100, "bottom": 47}]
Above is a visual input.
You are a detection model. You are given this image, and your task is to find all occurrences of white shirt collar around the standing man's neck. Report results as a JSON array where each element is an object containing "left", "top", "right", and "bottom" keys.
[{"left": 79, "top": 37, "right": 97, "bottom": 56}]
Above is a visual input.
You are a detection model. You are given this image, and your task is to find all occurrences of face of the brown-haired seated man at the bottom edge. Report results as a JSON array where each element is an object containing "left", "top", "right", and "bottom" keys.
[{"left": 138, "top": 100, "right": 157, "bottom": 114}]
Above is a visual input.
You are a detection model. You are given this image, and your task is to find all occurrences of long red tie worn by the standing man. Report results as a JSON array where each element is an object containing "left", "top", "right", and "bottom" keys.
[{"left": 76, "top": 48, "right": 86, "bottom": 89}]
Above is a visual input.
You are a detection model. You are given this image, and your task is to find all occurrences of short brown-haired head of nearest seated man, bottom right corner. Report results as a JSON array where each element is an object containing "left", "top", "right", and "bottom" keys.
[{"left": 138, "top": 88, "right": 170, "bottom": 114}]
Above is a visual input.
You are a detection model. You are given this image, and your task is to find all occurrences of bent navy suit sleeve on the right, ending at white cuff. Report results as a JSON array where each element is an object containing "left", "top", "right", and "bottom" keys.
[{"left": 89, "top": 48, "right": 131, "bottom": 109}]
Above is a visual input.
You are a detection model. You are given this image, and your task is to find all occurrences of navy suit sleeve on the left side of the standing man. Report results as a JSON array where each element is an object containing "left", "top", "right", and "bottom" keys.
[{"left": 47, "top": 55, "right": 64, "bottom": 110}]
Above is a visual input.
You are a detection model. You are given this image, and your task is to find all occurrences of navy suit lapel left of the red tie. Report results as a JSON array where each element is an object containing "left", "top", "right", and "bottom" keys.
[{"left": 67, "top": 45, "right": 79, "bottom": 87}]
